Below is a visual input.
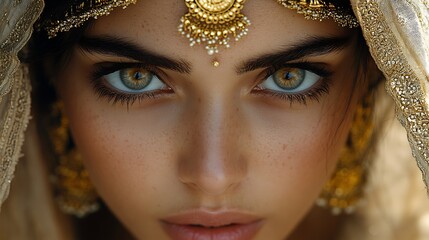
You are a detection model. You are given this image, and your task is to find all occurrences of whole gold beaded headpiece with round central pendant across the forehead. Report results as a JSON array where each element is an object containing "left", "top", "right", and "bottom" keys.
[{"left": 37, "top": 0, "right": 359, "bottom": 41}]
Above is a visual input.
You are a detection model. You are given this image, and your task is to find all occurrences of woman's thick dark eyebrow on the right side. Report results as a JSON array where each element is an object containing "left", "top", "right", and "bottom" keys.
[{"left": 236, "top": 36, "right": 352, "bottom": 74}]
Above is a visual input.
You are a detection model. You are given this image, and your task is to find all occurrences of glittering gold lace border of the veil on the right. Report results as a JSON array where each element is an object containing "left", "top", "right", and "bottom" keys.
[{"left": 357, "top": 0, "right": 429, "bottom": 191}]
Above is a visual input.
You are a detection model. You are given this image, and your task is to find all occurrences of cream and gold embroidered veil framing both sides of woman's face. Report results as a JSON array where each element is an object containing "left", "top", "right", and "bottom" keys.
[{"left": 0, "top": 0, "right": 429, "bottom": 215}]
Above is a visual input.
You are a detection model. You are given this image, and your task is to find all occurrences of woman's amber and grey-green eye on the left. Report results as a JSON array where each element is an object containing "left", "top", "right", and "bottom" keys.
[{"left": 103, "top": 68, "right": 166, "bottom": 94}]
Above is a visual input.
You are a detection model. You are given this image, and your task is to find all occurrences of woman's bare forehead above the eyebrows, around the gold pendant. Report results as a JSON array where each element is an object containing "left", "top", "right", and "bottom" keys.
[{"left": 88, "top": 0, "right": 351, "bottom": 62}]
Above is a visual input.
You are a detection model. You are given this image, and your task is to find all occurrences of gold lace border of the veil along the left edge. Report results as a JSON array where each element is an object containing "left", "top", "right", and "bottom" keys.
[{"left": 0, "top": 0, "right": 43, "bottom": 205}]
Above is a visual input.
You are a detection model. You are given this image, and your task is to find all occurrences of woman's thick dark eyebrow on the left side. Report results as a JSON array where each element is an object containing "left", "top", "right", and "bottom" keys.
[{"left": 78, "top": 36, "right": 191, "bottom": 74}]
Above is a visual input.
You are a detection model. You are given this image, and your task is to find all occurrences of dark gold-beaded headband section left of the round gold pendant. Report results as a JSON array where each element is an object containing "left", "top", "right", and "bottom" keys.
[{"left": 36, "top": 0, "right": 137, "bottom": 38}]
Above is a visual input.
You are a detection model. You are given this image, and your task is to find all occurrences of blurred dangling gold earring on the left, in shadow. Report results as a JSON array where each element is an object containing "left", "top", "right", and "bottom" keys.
[{"left": 50, "top": 102, "right": 98, "bottom": 217}]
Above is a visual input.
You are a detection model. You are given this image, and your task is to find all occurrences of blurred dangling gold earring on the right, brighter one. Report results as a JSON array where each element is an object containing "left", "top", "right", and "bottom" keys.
[{"left": 316, "top": 93, "right": 374, "bottom": 215}]
